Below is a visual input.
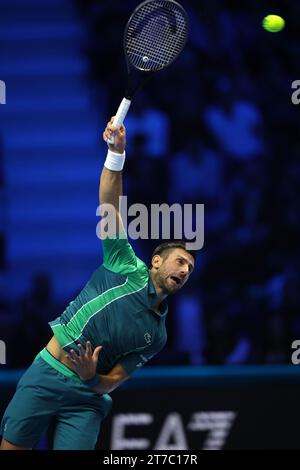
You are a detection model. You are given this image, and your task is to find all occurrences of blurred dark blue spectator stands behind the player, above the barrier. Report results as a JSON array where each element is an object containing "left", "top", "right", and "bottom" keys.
[{"left": 0, "top": 0, "right": 300, "bottom": 368}]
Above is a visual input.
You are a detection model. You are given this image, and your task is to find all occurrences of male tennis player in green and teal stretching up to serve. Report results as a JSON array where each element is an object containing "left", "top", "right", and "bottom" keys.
[{"left": 0, "top": 118, "right": 195, "bottom": 450}]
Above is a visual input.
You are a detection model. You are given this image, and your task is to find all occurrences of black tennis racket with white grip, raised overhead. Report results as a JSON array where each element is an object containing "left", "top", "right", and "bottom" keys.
[{"left": 108, "top": 0, "right": 189, "bottom": 144}]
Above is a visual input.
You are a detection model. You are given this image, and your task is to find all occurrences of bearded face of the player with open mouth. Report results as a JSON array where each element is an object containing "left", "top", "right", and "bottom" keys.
[{"left": 156, "top": 248, "right": 194, "bottom": 295}]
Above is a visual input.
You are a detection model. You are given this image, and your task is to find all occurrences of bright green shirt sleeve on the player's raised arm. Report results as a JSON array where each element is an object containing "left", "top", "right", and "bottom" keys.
[{"left": 102, "top": 236, "right": 137, "bottom": 274}]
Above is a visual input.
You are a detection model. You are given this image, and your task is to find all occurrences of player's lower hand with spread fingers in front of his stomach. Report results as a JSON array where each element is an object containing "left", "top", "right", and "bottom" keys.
[{"left": 66, "top": 341, "right": 102, "bottom": 381}]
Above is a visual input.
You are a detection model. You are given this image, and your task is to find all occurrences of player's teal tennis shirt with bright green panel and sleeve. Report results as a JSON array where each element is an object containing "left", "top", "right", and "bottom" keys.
[{"left": 49, "top": 238, "right": 168, "bottom": 374}]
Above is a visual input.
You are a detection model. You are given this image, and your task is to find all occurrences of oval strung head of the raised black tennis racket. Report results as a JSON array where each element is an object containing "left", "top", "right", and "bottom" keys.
[{"left": 125, "top": 0, "right": 188, "bottom": 71}]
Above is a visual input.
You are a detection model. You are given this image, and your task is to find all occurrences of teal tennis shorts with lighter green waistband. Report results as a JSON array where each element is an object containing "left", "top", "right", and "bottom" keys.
[{"left": 0, "top": 349, "right": 112, "bottom": 450}]
